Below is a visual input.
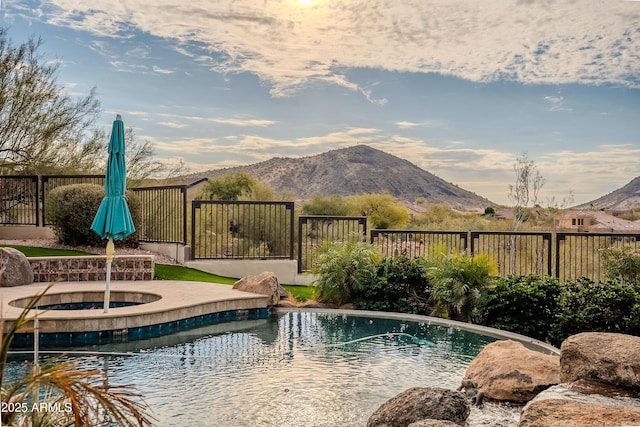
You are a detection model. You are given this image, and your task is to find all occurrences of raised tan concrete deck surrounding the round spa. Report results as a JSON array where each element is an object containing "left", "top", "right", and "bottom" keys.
[{"left": 0, "top": 280, "right": 268, "bottom": 334}]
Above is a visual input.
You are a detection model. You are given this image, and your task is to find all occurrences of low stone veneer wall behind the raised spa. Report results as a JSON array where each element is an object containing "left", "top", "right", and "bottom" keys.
[{"left": 29, "top": 255, "right": 154, "bottom": 282}]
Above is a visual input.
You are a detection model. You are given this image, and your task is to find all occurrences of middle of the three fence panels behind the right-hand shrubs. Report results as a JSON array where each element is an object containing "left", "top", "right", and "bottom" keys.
[{"left": 470, "top": 231, "right": 553, "bottom": 276}]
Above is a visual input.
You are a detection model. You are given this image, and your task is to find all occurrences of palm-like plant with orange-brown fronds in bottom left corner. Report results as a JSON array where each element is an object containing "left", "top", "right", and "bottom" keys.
[{"left": 0, "top": 285, "right": 152, "bottom": 427}]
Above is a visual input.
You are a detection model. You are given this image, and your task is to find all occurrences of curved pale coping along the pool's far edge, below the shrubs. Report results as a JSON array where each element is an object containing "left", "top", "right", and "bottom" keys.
[{"left": 277, "top": 307, "right": 560, "bottom": 356}]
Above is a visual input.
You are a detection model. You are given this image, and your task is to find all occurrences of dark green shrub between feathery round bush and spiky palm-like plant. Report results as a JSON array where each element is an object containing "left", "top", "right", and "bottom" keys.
[{"left": 352, "top": 256, "right": 431, "bottom": 314}]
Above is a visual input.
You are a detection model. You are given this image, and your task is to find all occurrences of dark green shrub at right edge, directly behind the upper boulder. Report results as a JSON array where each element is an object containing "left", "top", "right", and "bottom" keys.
[{"left": 550, "top": 278, "right": 640, "bottom": 345}]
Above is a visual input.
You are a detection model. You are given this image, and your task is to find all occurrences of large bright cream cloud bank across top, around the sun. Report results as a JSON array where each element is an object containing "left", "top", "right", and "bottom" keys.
[{"left": 33, "top": 0, "right": 640, "bottom": 98}]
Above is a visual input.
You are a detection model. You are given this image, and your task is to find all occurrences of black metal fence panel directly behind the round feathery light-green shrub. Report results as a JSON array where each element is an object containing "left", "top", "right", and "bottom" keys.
[{"left": 298, "top": 215, "right": 367, "bottom": 273}]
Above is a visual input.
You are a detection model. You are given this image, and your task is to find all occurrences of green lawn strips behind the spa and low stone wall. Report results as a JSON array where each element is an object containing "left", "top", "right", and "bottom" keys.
[{"left": 0, "top": 245, "right": 313, "bottom": 302}]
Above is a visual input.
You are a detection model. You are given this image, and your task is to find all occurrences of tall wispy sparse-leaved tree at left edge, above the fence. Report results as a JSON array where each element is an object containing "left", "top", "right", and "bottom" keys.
[{"left": 0, "top": 28, "right": 106, "bottom": 174}]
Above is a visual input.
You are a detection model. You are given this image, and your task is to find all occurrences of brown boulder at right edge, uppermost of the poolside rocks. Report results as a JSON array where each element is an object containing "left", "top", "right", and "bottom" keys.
[{"left": 560, "top": 332, "right": 640, "bottom": 390}]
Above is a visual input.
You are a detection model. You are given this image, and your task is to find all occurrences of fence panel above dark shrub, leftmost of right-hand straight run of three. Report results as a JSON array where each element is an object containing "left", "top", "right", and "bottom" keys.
[{"left": 371, "top": 230, "right": 468, "bottom": 258}]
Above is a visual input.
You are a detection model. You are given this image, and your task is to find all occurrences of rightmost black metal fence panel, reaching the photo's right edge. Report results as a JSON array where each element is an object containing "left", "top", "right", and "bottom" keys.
[{"left": 555, "top": 233, "right": 640, "bottom": 282}]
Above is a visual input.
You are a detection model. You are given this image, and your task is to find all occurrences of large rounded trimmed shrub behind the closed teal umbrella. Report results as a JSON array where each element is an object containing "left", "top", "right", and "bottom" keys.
[{"left": 46, "top": 184, "right": 140, "bottom": 247}]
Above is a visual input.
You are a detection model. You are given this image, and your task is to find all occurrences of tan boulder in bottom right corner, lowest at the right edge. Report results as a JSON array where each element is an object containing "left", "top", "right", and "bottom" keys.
[{"left": 518, "top": 383, "right": 640, "bottom": 427}]
